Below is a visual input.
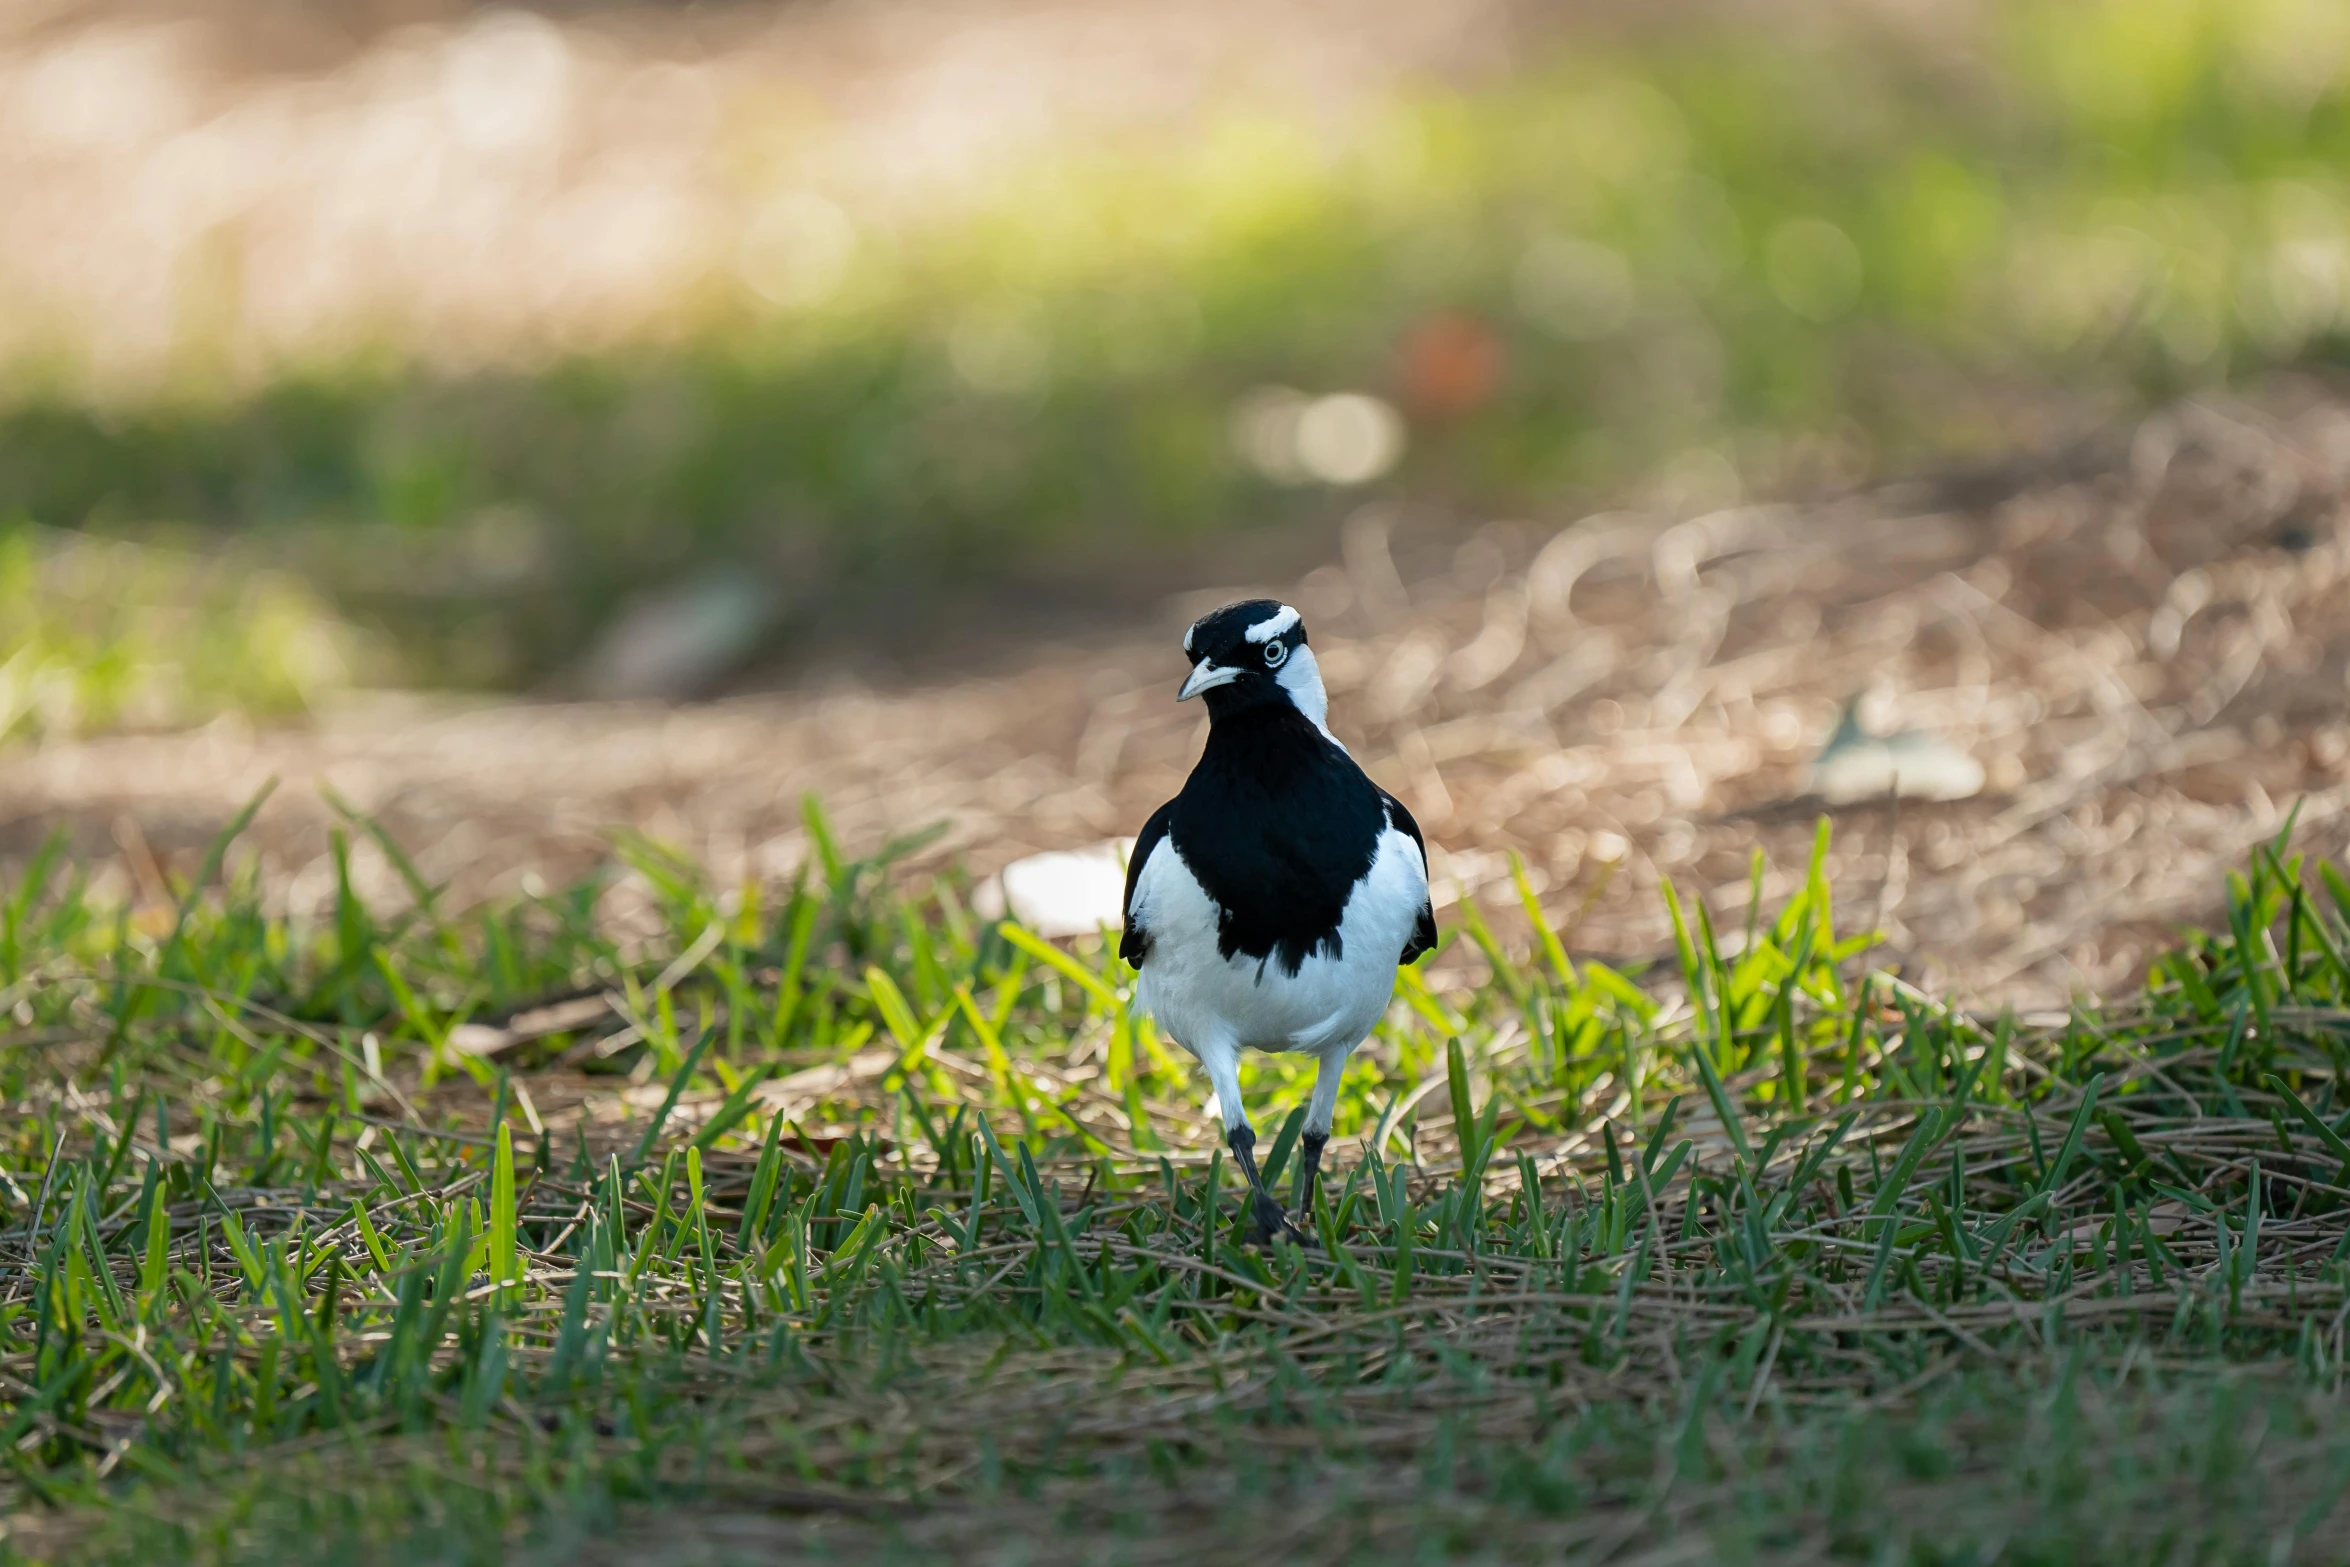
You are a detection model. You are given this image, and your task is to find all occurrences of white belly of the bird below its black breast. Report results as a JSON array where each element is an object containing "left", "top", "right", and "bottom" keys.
[{"left": 1135, "top": 827, "right": 1429, "bottom": 1060}]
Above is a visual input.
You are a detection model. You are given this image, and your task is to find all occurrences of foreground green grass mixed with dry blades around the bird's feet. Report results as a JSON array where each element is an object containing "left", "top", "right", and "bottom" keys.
[{"left": 0, "top": 815, "right": 2350, "bottom": 1560}]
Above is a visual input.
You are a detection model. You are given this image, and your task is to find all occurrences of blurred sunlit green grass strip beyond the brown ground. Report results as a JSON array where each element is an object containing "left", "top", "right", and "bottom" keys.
[{"left": 0, "top": 0, "right": 2350, "bottom": 684}]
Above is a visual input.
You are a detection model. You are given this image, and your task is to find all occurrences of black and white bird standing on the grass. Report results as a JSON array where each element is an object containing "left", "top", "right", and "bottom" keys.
[{"left": 1119, "top": 599, "right": 1436, "bottom": 1240}]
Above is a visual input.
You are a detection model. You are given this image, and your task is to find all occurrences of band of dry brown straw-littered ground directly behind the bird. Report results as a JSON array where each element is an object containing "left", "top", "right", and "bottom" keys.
[{"left": 0, "top": 385, "right": 2350, "bottom": 1006}]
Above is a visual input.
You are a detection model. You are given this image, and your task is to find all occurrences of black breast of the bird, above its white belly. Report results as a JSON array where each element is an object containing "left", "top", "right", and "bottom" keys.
[{"left": 1168, "top": 702, "right": 1387, "bottom": 975}]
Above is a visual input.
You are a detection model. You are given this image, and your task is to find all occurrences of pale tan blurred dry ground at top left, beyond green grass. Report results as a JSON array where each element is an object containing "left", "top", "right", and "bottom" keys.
[{"left": 0, "top": 0, "right": 1523, "bottom": 385}]
